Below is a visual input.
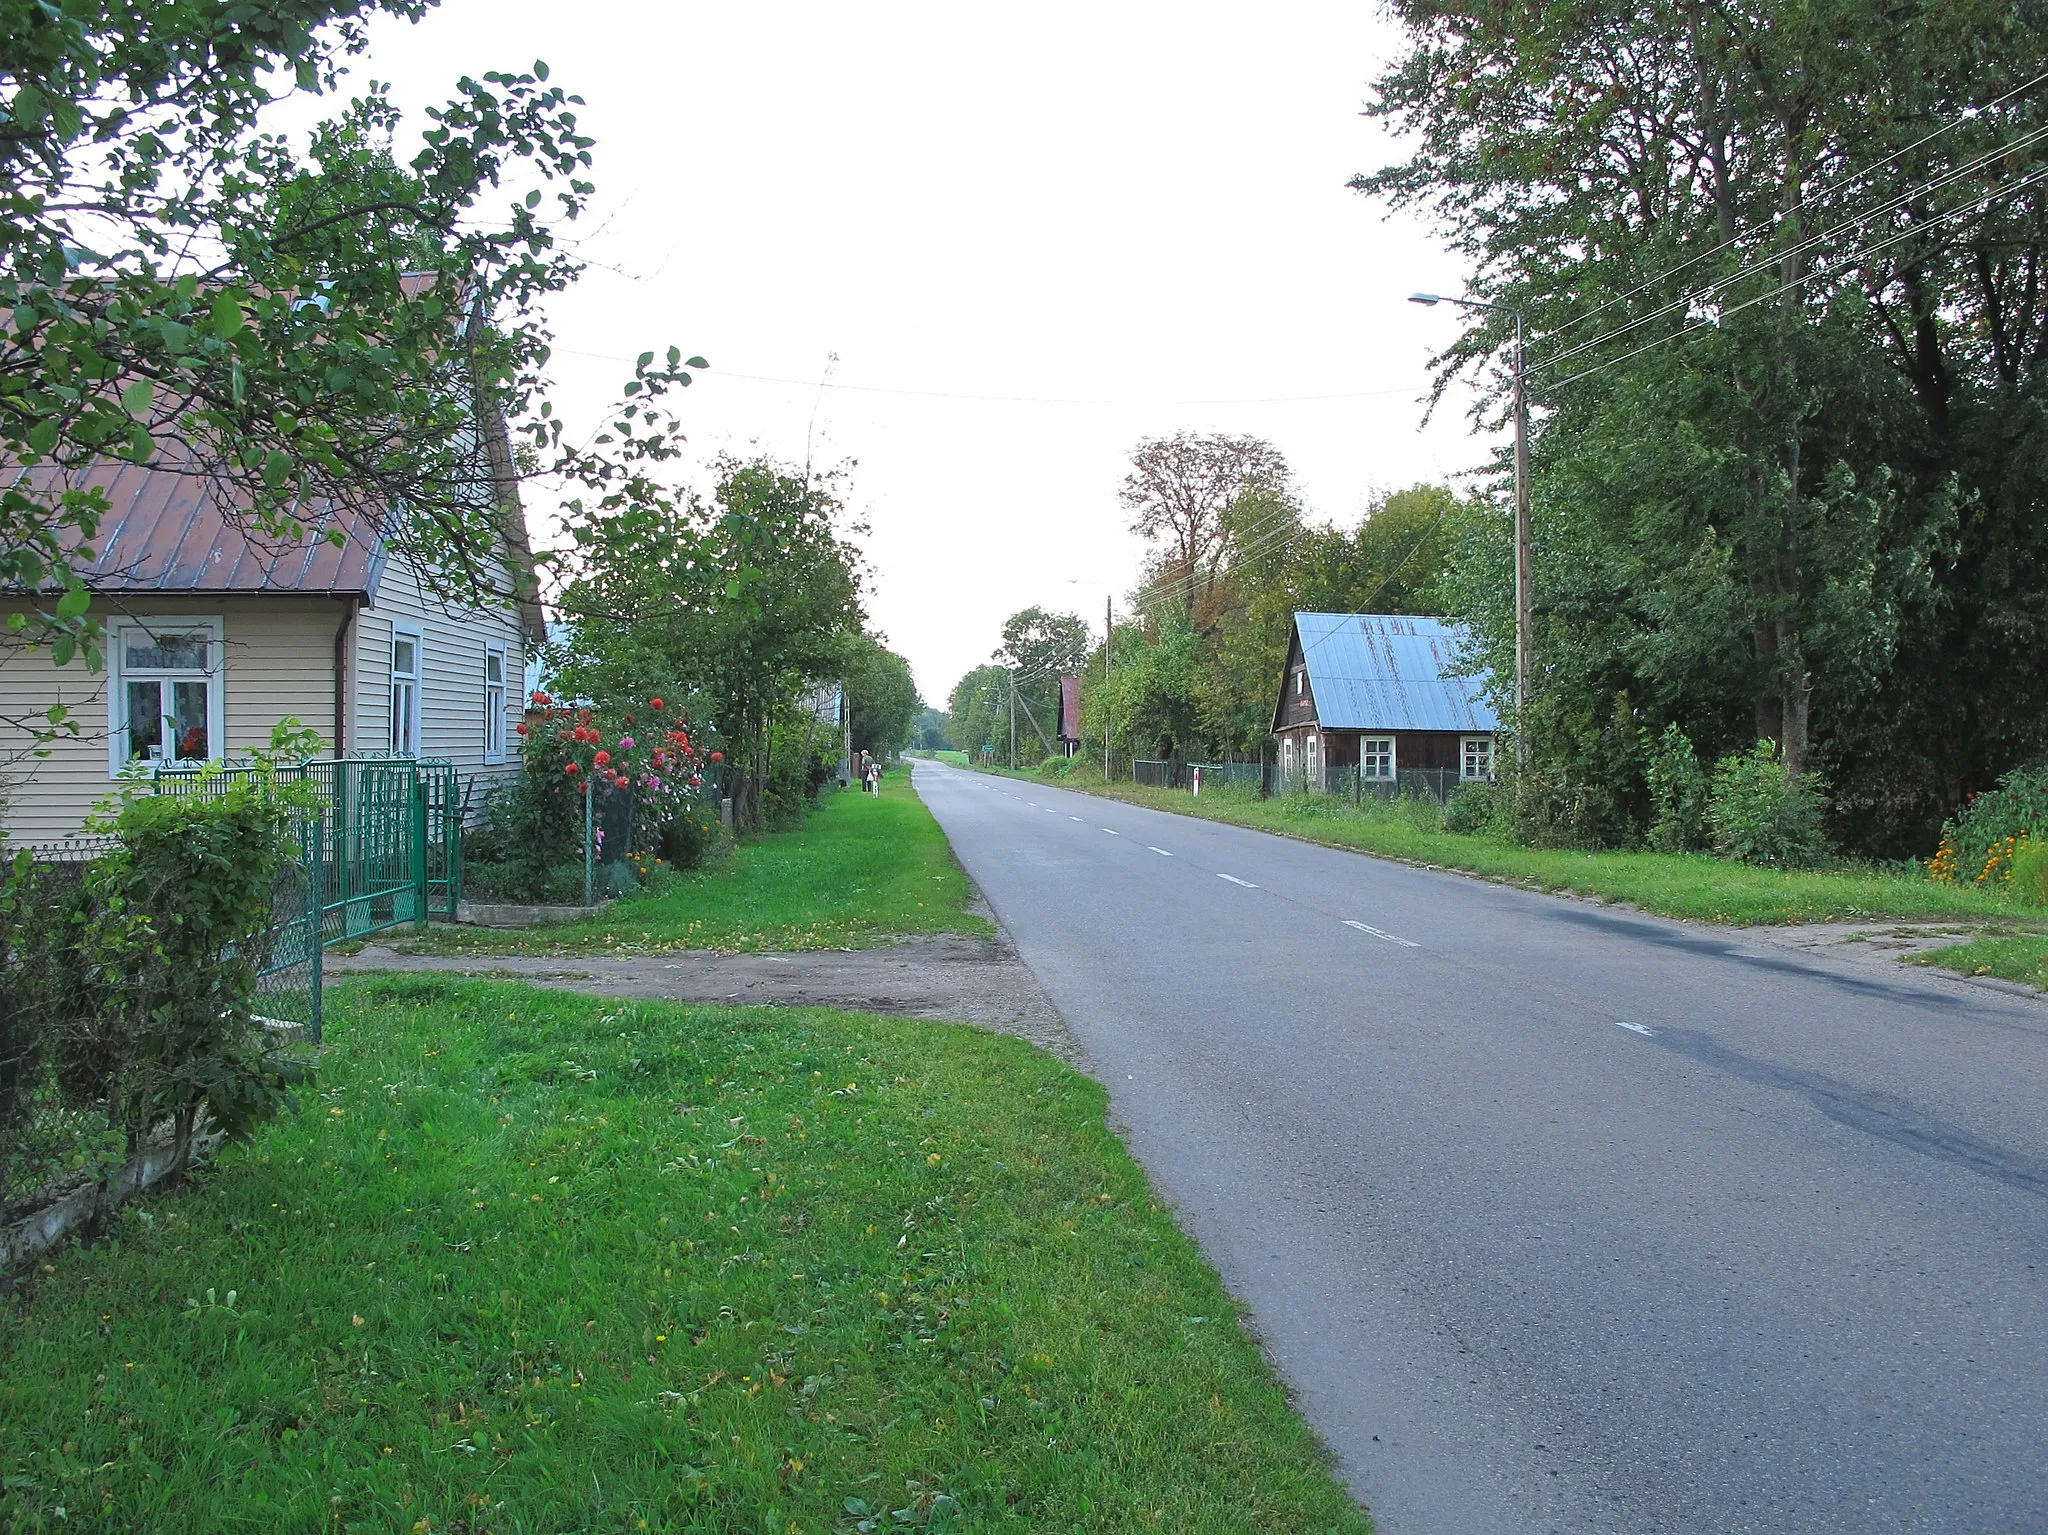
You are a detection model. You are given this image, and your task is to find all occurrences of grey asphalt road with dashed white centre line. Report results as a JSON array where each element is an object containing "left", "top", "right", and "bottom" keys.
[{"left": 915, "top": 763, "right": 2048, "bottom": 1535}]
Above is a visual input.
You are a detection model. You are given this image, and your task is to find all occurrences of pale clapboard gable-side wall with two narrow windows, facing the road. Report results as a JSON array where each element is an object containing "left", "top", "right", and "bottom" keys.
[{"left": 348, "top": 559, "right": 526, "bottom": 802}]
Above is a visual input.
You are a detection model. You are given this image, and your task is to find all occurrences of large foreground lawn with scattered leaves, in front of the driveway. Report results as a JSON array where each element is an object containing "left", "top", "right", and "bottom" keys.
[{"left": 0, "top": 976, "right": 1368, "bottom": 1535}]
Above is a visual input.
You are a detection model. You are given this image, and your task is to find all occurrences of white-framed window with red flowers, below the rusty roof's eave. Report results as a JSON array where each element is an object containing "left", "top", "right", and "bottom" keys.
[{"left": 106, "top": 618, "right": 225, "bottom": 774}]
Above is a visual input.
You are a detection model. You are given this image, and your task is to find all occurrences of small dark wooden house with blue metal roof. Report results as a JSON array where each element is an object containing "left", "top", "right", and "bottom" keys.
[{"left": 1274, "top": 612, "right": 1499, "bottom": 790}]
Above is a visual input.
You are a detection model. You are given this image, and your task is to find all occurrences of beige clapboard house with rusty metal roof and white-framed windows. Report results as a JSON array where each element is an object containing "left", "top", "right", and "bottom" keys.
[{"left": 0, "top": 436, "right": 543, "bottom": 845}]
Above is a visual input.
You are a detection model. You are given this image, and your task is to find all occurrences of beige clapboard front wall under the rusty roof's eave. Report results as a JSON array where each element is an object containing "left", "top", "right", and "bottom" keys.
[{"left": 0, "top": 596, "right": 342, "bottom": 843}]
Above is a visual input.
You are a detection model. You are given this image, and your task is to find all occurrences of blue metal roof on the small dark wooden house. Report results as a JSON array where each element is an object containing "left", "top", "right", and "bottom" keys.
[{"left": 1294, "top": 612, "right": 1499, "bottom": 731}]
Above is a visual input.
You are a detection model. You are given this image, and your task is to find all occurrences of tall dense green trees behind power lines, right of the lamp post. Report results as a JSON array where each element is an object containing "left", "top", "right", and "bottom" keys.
[{"left": 1356, "top": 0, "right": 2048, "bottom": 851}]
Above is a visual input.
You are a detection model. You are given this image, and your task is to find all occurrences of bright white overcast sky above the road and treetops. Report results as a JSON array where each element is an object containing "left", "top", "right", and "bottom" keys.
[{"left": 331, "top": 0, "right": 1485, "bottom": 706}]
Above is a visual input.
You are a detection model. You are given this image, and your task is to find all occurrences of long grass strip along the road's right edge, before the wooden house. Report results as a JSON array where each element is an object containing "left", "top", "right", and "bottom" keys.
[{"left": 966, "top": 768, "right": 2032, "bottom": 927}]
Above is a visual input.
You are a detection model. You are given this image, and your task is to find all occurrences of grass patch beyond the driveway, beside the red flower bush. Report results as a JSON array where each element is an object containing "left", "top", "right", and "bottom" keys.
[{"left": 421, "top": 768, "right": 989, "bottom": 954}]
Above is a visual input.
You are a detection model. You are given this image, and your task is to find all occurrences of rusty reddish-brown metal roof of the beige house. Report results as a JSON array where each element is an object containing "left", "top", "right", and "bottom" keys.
[{"left": 16, "top": 448, "right": 387, "bottom": 598}]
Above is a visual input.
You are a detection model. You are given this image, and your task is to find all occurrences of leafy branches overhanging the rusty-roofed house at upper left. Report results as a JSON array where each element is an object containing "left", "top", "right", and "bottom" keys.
[{"left": 0, "top": 0, "right": 702, "bottom": 735}]
